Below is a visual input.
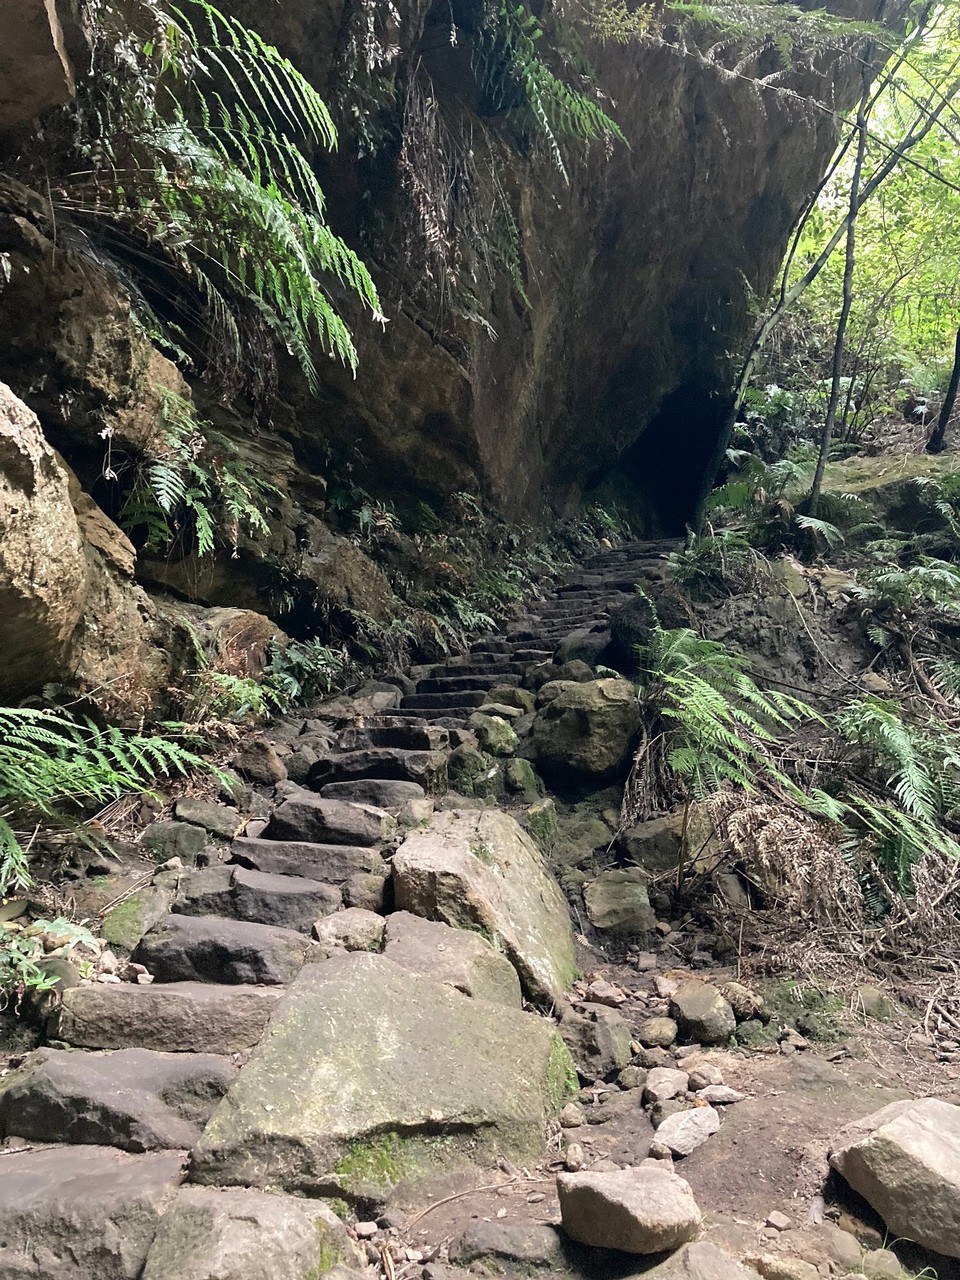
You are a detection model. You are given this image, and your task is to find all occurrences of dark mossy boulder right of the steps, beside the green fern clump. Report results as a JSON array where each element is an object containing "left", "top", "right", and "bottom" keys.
[{"left": 529, "top": 680, "right": 640, "bottom": 783}]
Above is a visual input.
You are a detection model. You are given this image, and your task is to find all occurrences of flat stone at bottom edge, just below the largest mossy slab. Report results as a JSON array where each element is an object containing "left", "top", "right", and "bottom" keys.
[{"left": 143, "top": 1187, "right": 366, "bottom": 1280}]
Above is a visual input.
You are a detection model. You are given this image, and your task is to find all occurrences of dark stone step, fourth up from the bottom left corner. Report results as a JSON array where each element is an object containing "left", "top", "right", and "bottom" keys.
[{"left": 133, "top": 915, "right": 310, "bottom": 986}]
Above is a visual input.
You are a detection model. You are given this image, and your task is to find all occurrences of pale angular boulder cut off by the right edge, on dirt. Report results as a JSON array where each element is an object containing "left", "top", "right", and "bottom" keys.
[{"left": 829, "top": 1098, "right": 960, "bottom": 1258}]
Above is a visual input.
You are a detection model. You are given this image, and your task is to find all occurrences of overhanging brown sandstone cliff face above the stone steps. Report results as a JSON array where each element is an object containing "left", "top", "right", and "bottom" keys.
[{"left": 232, "top": 0, "right": 865, "bottom": 527}]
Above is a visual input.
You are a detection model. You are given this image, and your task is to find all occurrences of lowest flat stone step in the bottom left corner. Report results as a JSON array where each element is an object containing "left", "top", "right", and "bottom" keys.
[{"left": 0, "top": 1147, "right": 184, "bottom": 1280}]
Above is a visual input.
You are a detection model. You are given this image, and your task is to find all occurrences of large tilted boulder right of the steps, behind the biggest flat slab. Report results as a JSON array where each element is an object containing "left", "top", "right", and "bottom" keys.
[{"left": 393, "top": 809, "right": 575, "bottom": 1001}]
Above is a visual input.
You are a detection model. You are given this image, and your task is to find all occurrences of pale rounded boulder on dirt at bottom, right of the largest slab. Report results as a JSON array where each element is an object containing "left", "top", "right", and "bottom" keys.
[{"left": 557, "top": 1165, "right": 700, "bottom": 1253}]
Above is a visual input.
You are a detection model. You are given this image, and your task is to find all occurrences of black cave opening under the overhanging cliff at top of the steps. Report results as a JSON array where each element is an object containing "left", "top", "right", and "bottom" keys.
[{"left": 617, "top": 384, "right": 727, "bottom": 536}]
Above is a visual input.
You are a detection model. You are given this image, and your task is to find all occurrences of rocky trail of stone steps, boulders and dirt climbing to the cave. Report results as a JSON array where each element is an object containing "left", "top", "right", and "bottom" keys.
[{"left": 0, "top": 543, "right": 960, "bottom": 1280}]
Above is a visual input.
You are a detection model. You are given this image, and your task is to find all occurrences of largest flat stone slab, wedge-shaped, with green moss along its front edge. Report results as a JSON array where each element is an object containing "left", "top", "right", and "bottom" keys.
[{"left": 192, "top": 952, "right": 572, "bottom": 1197}]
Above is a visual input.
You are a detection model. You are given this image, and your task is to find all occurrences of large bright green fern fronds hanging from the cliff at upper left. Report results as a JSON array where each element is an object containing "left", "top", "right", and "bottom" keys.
[{"left": 55, "top": 0, "right": 380, "bottom": 392}]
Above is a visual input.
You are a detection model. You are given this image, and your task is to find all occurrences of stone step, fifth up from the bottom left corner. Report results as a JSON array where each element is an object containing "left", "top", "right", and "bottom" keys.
[{"left": 171, "top": 867, "right": 343, "bottom": 936}]
